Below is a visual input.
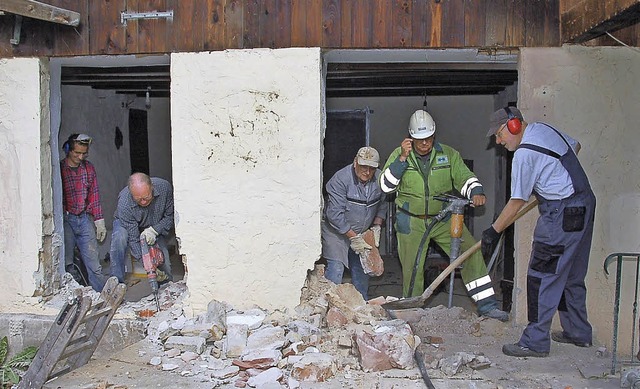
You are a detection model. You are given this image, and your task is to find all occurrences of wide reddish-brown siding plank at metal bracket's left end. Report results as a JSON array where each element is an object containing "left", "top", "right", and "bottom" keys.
[{"left": 89, "top": 0, "right": 127, "bottom": 54}]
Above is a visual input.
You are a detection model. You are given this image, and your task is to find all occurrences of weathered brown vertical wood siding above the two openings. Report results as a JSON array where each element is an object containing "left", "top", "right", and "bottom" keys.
[{"left": 0, "top": 0, "right": 560, "bottom": 57}]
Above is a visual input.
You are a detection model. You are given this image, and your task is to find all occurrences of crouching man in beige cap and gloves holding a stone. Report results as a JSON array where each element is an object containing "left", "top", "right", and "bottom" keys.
[{"left": 322, "top": 147, "right": 386, "bottom": 300}]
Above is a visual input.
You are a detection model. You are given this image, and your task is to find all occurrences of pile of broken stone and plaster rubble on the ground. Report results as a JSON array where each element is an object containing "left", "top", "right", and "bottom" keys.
[{"left": 104, "top": 265, "right": 500, "bottom": 388}]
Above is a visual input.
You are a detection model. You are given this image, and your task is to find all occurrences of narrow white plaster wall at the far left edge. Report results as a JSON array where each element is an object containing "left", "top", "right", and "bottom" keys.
[{"left": 0, "top": 58, "right": 46, "bottom": 312}]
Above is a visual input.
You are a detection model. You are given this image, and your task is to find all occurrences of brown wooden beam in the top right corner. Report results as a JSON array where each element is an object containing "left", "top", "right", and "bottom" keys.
[{"left": 561, "top": 0, "right": 640, "bottom": 43}]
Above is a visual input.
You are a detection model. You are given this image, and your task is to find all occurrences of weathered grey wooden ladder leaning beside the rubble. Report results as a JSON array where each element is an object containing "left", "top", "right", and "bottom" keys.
[{"left": 18, "top": 277, "right": 127, "bottom": 389}]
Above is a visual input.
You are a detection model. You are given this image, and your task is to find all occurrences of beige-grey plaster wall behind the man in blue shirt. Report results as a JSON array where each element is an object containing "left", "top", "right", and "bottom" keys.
[{"left": 515, "top": 46, "right": 640, "bottom": 352}]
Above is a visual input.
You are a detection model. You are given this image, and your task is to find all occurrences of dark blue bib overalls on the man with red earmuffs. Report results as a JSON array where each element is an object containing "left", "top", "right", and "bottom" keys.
[{"left": 518, "top": 130, "right": 596, "bottom": 352}]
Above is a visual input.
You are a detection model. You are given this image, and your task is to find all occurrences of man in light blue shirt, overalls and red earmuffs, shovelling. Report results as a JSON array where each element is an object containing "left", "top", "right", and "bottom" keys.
[{"left": 482, "top": 107, "right": 596, "bottom": 357}]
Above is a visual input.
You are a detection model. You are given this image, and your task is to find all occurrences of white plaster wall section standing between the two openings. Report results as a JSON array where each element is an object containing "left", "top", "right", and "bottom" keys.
[{"left": 171, "top": 48, "right": 324, "bottom": 313}]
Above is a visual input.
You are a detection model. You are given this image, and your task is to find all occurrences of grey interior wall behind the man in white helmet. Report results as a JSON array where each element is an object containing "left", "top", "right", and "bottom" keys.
[{"left": 327, "top": 96, "right": 495, "bottom": 238}]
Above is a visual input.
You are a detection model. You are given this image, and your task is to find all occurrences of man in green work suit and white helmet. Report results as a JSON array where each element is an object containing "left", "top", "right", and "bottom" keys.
[{"left": 380, "top": 110, "right": 509, "bottom": 321}]
